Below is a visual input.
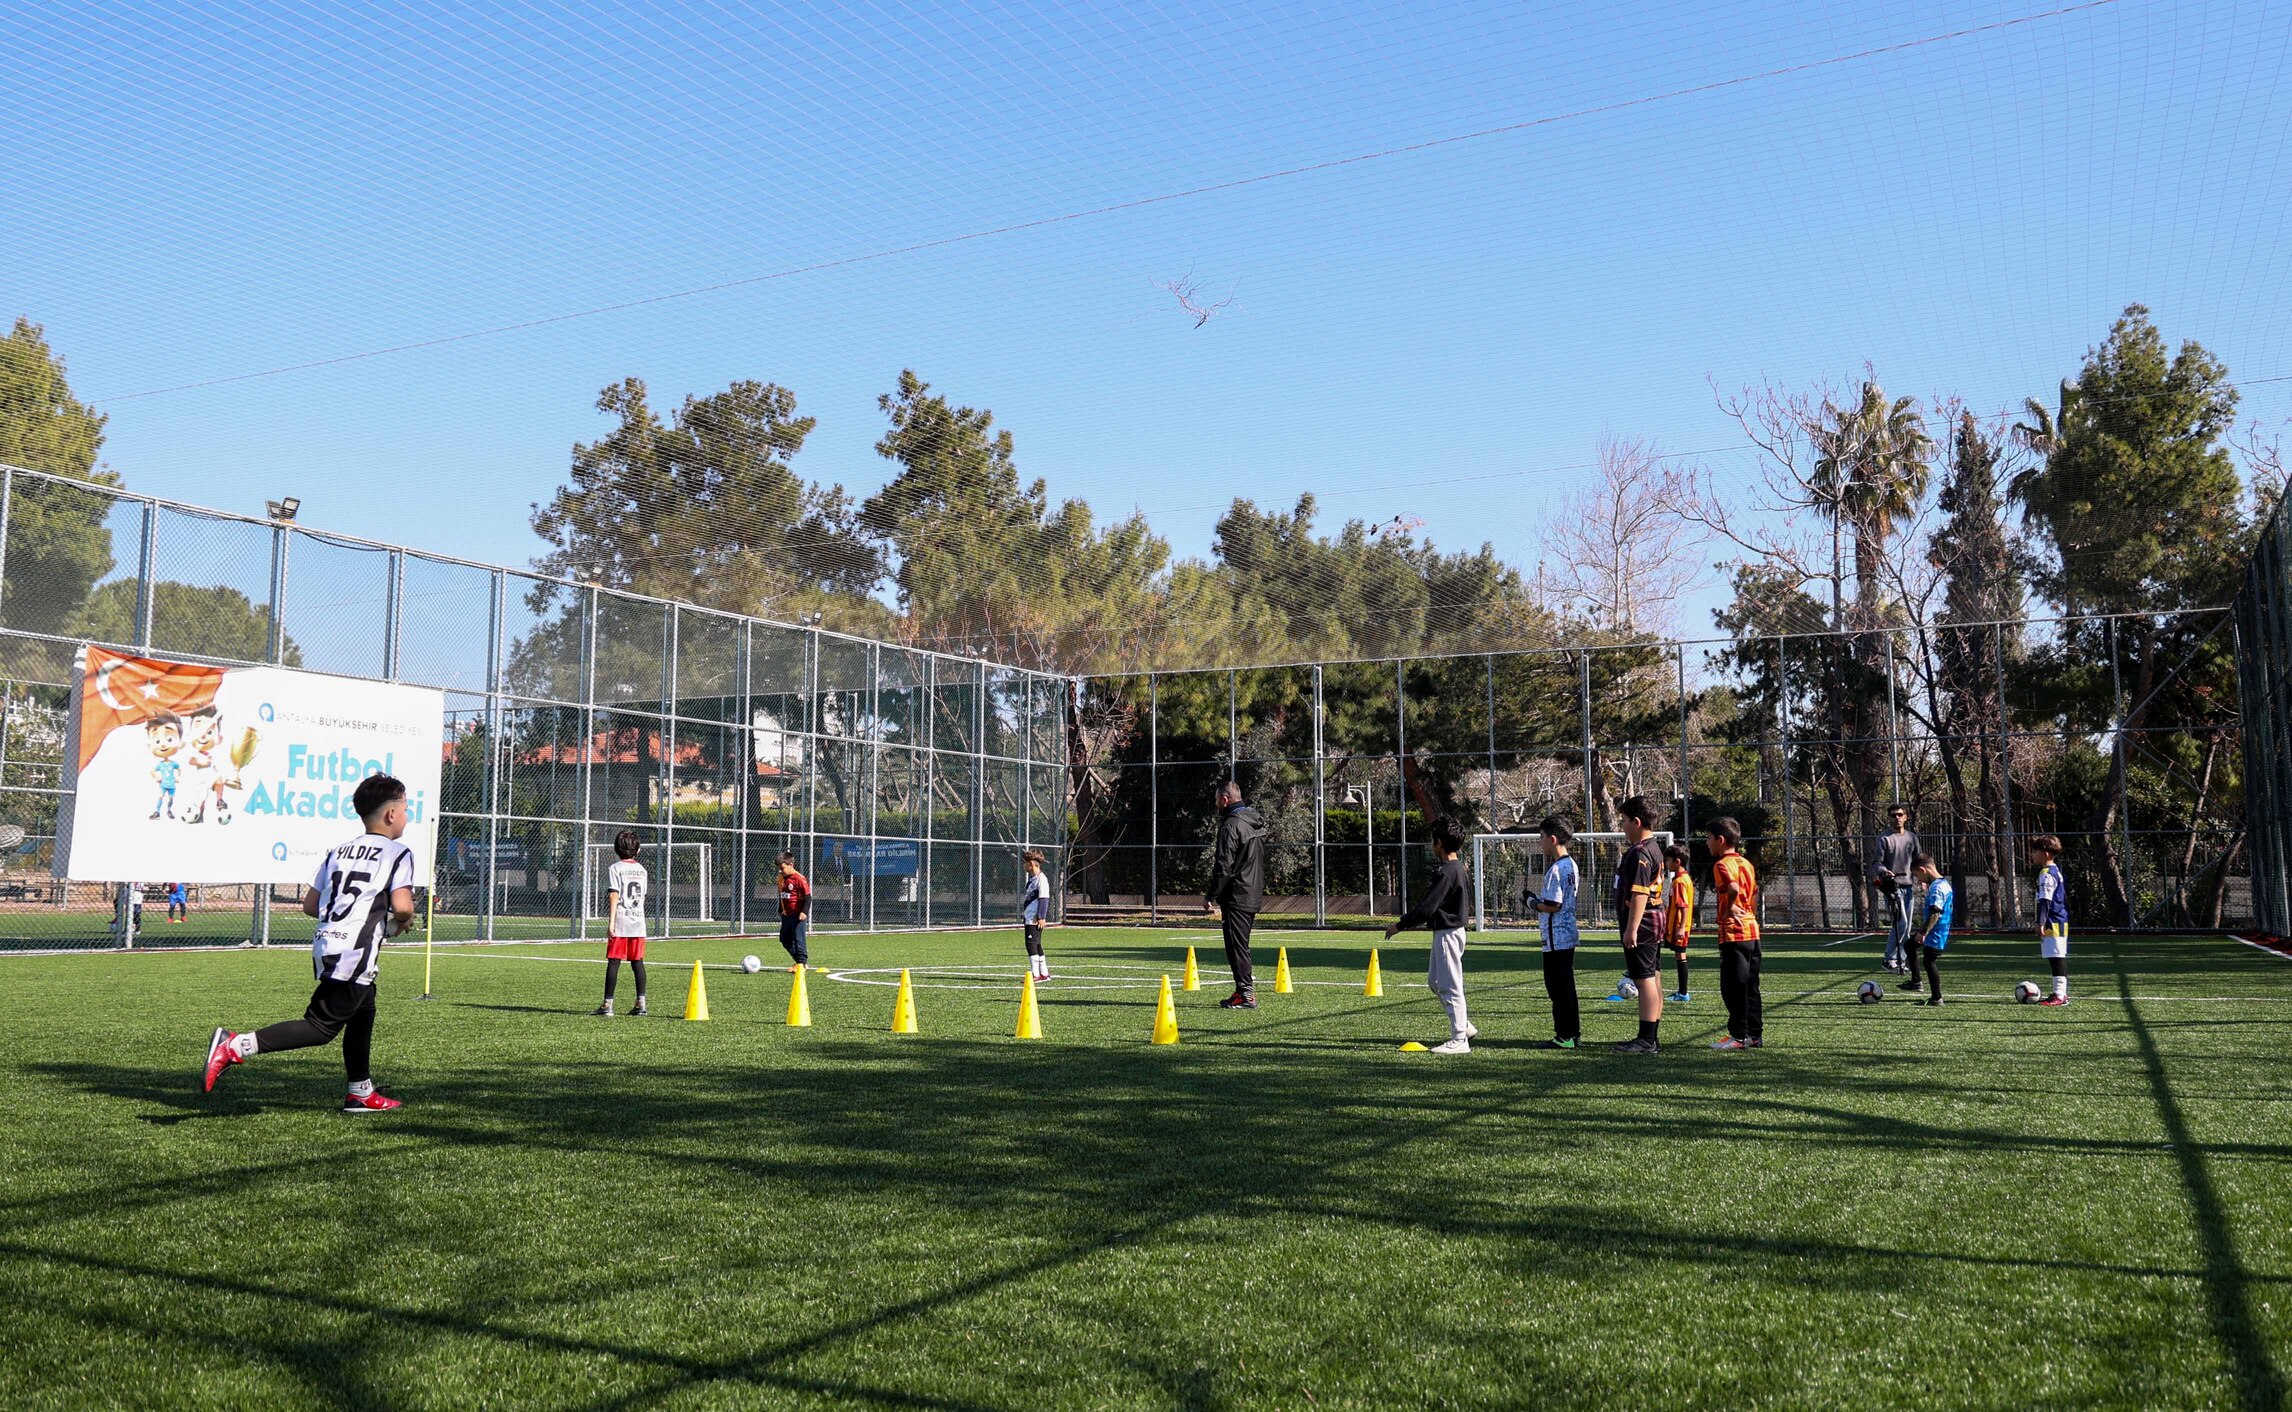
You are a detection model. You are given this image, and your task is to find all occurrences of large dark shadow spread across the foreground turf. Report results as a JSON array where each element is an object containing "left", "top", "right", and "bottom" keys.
[{"left": 0, "top": 939, "right": 2283, "bottom": 1410}]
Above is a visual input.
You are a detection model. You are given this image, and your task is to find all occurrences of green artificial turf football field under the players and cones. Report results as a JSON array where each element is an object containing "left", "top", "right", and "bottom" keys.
[{"left": 0, "top": 928, "right": 2292, "bottom": 1412}]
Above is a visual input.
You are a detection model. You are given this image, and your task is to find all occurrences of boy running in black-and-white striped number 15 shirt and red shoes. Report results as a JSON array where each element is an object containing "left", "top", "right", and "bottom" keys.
[{"left": 204, "top": 775, "right": 415, "bottom": 1114}]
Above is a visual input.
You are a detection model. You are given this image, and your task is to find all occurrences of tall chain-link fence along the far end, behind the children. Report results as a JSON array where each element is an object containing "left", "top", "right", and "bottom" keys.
[{"left": 1068, "top": 610, "right": 2255, "bottom": 931}]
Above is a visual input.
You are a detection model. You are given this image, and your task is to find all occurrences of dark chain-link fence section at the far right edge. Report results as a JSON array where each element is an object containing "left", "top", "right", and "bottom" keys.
[{"left": 2237, "top": 490, "right": 2292, "bottom": 940}]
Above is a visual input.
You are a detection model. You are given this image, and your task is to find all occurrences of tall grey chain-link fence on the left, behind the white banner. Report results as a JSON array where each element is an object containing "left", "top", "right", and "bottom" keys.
[{"left": 0, "top": 468, "right": 1070, "bottom": 949}]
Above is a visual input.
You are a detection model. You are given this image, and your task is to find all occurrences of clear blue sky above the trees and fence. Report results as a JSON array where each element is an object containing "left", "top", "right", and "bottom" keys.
[{"left": 0, "top": 0, "right": 2292, "bottom": 628}]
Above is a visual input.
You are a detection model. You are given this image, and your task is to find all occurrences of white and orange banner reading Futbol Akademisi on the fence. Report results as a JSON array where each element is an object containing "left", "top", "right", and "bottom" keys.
[{"left": 55, "top": 646, "right": 445, "bottom": 887}]
